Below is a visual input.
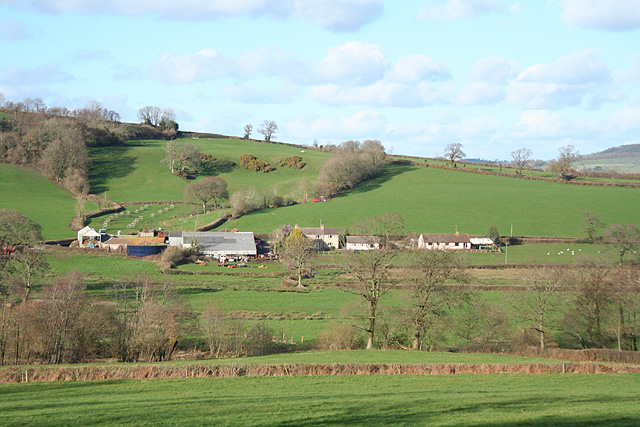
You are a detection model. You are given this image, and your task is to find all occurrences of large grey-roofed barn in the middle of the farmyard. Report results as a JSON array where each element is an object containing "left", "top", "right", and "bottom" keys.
[{"left": 175, "top": 231, "right": 257, "bottom": 258}]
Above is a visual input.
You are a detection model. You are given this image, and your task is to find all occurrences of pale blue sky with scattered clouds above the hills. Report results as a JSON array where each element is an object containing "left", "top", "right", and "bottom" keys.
[{"left": 0, "top": 0, "right": 640, "bottom": 160}]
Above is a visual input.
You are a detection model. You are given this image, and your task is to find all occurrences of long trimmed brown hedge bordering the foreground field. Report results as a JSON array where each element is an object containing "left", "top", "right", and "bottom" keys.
[{"left": 0, "top": 362, "right": 640, "bottom": 384}]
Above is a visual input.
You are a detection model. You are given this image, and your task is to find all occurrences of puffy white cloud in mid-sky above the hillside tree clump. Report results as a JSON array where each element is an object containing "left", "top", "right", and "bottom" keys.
[{"left": 316, "top": 42, "right": 389, "bottom": 85}]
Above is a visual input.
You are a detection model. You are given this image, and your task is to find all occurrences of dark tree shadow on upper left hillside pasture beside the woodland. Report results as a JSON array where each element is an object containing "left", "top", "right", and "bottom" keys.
[{"left": 89, "top": 146, "right": 136, "bottom": 194}]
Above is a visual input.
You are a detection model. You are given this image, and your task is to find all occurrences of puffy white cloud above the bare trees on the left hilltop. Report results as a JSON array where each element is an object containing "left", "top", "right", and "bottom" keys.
[{"left": 151, "top": 49, "right": 236, "bottom": 84}]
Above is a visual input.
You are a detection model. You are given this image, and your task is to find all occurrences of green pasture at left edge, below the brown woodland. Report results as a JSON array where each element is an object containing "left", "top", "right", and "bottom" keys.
[{"left": 0, "top": 164, "right": 76, "bottom": 239}]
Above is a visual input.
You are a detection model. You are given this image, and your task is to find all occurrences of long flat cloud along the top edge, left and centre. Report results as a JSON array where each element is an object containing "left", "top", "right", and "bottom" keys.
[{"left": 5, "top": 0, "right": 383, "bottom": 31}]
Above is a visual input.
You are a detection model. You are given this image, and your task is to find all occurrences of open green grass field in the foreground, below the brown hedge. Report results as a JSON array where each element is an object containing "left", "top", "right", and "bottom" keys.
[{"left": 0, "top": 374, "right": 640, "bottom": 427}]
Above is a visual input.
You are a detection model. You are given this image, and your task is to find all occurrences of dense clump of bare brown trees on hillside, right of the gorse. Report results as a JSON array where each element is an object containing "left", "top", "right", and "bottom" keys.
[{"left": 317, "top": 140, "right": 387, "bottom": 196}]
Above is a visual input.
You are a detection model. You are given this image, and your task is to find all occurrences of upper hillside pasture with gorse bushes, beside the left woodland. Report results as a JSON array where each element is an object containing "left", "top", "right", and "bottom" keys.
[{"left": 89, "top": 138, "right": 329, "bottom": 202}]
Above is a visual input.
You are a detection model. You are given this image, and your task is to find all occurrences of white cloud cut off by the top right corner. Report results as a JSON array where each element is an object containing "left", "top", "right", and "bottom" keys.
[{"left": 561, "top": 0, "right": 640, "bottom": 31}]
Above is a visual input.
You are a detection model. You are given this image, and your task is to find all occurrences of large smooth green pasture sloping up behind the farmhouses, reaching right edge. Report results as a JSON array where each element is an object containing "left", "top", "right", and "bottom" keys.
[{"left": 225, "top": 165, "right": 640, "bottom": 237}]
